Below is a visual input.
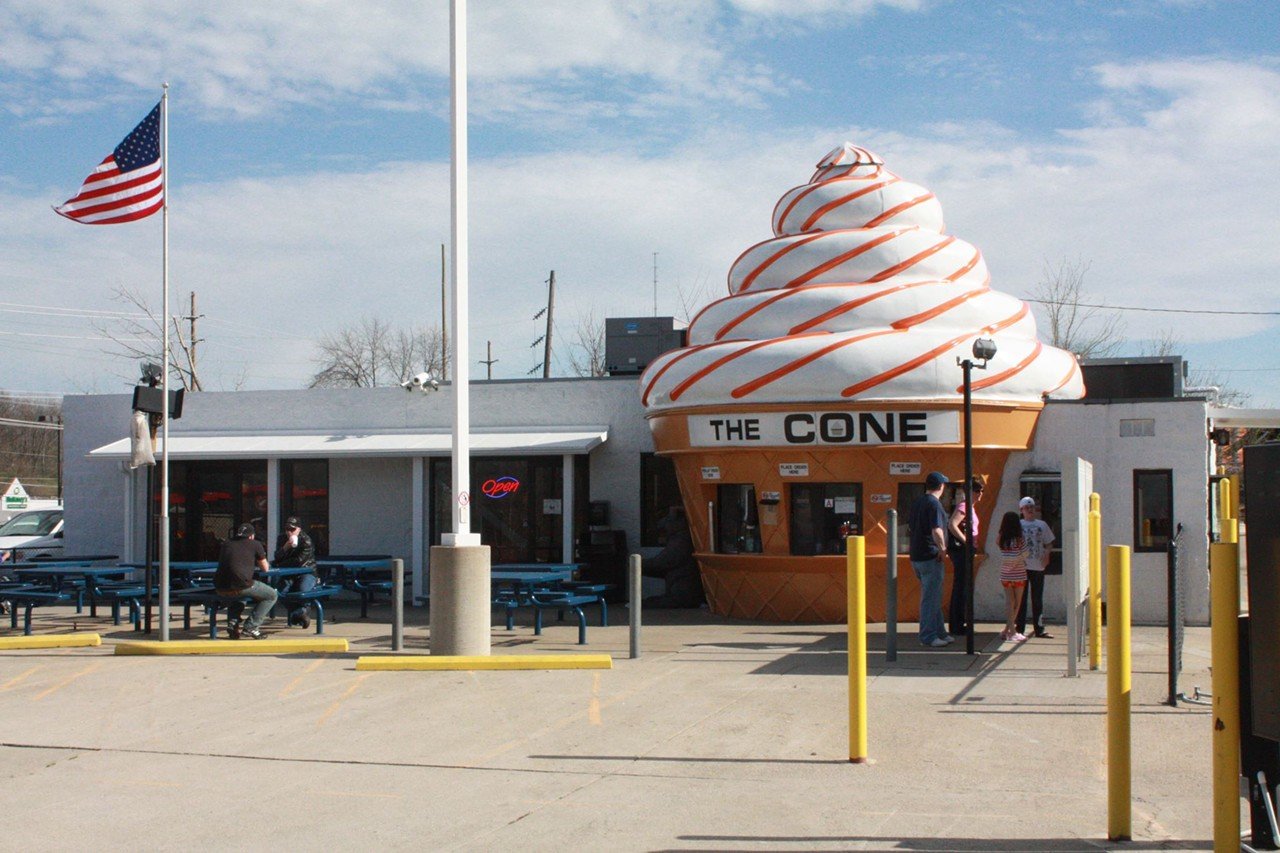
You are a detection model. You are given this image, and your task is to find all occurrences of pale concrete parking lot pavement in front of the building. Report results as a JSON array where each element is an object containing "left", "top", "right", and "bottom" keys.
[{"left": 0, "top": 608, "right": 1218, "bottom": 850}]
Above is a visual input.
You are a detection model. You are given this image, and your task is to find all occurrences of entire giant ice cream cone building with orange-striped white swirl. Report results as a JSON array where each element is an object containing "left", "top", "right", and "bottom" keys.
[{"left": 640, "top": 143, "right": 1084, "bottom": 621}]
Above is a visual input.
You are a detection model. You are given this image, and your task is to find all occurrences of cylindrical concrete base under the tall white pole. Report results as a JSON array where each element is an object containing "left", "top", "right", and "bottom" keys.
[{"left": 430, "top": 546, "right": 490, "bottom": 654}]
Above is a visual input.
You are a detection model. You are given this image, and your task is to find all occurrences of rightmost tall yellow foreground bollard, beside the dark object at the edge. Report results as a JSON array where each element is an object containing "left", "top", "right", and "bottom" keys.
[{"left": 1208, "top": 542, "right": 1240, "bottom": 850}]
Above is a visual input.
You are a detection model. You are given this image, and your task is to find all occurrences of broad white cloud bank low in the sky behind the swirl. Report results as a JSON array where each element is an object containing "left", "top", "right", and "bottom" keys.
[{"left": 0, "top": 61, "right": 1280, "bottom": 399}]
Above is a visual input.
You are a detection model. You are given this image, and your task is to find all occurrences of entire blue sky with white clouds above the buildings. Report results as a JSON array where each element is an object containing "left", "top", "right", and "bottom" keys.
[{"left": 0, "top": 0, "right": 1280, "bottom": 406}]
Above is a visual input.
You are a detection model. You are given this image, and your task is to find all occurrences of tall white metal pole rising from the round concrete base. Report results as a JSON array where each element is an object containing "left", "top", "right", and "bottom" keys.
[{"left": 443, "top": 0, "right": 480, "bottom": 546}]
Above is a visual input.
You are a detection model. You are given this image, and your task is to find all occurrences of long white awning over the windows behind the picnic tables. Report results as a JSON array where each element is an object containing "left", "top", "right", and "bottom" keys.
[{"left": 90, "top": 427, "right": 609, "bottom": 460}]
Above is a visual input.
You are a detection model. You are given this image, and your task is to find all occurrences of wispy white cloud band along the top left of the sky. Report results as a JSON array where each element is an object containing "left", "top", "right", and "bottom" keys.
[{"left": 0, "top": 0, "right": 829, "bottom": 118}]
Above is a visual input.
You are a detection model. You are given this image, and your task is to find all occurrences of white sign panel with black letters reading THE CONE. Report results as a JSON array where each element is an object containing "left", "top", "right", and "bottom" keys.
[{"left": 687, "top": 411, "right": 960, "bottom": 447}]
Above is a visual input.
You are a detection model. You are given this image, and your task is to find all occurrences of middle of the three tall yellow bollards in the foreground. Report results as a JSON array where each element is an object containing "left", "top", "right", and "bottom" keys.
[{"left": 1107, "top": 546, "right": 1133, "bottom": 841}]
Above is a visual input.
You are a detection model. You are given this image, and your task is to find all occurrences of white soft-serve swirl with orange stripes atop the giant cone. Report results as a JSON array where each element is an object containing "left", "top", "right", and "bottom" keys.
[{"left": 641, "top": 142, "right": 1084, "bottom": 410}]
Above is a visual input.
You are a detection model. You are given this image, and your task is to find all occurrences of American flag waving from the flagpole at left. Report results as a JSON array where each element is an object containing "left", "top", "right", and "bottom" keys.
[{"left": 54, "top": 104, "right": 164, "bottom": 225}]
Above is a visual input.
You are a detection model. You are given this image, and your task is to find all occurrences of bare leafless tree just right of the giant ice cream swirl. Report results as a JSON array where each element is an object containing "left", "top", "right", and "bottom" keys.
[{"left": 1030, "top": 253, "right": 1124, "bottom": 359}]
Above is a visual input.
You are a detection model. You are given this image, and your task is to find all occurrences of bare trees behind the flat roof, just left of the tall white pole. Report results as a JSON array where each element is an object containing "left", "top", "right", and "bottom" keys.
[{"left": 308, "top": 318, "right": 444, "bottom": 388}]
